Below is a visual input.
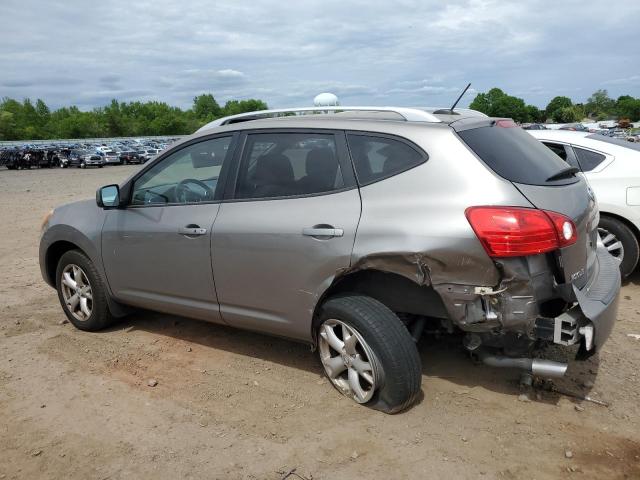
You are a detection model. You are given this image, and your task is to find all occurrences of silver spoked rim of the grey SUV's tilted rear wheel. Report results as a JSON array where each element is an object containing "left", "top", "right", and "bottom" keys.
[{"left": 318, "top": 319, "right": 378, "bottom": 403}]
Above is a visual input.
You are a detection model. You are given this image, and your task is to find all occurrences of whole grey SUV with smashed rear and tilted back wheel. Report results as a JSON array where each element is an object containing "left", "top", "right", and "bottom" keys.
[{"left": 40, "top": 107, "right": 620, "bottom": 413}]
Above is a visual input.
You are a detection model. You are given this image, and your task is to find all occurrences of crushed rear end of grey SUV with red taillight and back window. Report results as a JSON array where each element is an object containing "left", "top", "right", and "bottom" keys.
[{"left": 435, "top": 119, "right": 620, "bottom": 376}]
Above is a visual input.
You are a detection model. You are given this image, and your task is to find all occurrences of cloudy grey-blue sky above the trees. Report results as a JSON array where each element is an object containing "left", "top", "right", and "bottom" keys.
[{"left": 0, "top": 0, "right": 640, "bottom": 109}]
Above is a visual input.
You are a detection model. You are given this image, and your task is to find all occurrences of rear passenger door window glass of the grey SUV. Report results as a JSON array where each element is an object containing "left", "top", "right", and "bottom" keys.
[{"left": 235, "top": 132, "right": 345, "bottom": 199}]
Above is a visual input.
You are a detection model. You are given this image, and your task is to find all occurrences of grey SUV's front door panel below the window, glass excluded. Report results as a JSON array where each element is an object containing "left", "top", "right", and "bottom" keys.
[{"left": 102, "top": 203, "right": 221, "bottom": 322}]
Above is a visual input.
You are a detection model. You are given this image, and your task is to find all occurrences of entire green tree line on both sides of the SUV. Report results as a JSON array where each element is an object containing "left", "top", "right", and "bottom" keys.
[{"left": 0, "top": 88, "right": 640, "bottom": 140}]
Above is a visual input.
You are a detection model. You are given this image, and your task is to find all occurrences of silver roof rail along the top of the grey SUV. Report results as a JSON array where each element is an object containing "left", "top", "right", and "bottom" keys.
[{"left": 198, "top": 105, "right": 442, "bottom": 132}]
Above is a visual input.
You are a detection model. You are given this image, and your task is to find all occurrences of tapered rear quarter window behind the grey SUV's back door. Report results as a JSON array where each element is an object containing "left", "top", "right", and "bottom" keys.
[{"left": 347, "top": 134, "right": 427, "bottom": 185}]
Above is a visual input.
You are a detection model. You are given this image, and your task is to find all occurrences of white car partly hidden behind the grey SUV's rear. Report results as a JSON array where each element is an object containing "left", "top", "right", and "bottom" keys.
[{"left": 529, "top": 130, "right": 640, "bottom": 278}]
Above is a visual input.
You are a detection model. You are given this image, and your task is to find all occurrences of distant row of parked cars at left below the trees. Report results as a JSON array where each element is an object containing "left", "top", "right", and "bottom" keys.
[{"left": 0, "top": 140, "right": 180, "bottom": 170}]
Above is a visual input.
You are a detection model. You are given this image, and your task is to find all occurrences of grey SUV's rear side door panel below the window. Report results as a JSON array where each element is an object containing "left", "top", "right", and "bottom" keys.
[{"left": 213, "top": 189, "right": 360, "bottom": 340}]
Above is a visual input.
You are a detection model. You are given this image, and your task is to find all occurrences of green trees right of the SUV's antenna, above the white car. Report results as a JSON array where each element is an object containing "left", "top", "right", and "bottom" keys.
[{"left": 469, "top": 88, "right": 640, "bottom": 123}]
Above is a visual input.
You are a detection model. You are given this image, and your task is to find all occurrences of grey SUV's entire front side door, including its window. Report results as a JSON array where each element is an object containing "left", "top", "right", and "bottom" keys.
[{"left": 102, "top": 134, "right": 235, "bottom": 322}]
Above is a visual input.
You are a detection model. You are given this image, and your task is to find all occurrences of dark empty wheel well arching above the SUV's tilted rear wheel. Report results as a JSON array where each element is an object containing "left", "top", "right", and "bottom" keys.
[{"left": 312, "top": 270, "right": 447, "bottom": 337}]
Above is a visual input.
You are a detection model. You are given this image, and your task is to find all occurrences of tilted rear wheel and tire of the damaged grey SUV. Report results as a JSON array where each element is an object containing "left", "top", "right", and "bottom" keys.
[{"left": 317, "top": 295, "right": 422, "bottom": 414}]
